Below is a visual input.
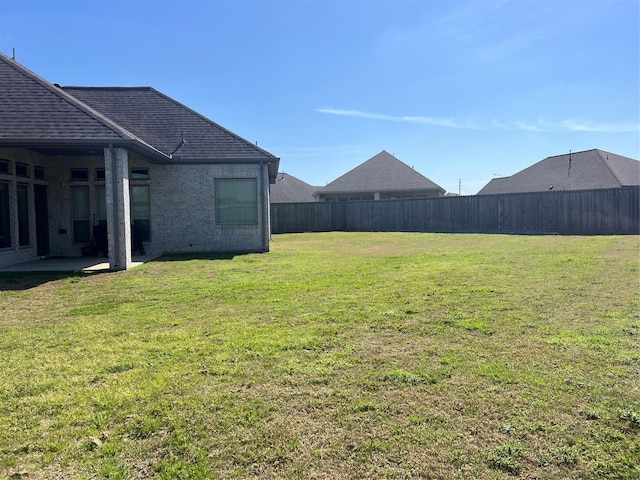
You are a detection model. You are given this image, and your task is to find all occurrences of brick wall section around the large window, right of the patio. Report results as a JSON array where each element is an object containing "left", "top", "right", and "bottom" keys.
[{"left": 147, "top": 164, "right": 270, "bottom": 254}]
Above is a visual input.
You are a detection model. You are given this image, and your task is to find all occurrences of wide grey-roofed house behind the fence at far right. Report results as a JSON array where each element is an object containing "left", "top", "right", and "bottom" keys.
[{"left": 478, "top": 149, "right": 640, "bottom": 195}]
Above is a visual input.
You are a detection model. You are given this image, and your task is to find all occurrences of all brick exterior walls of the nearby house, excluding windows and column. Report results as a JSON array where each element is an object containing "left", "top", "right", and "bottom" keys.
[{"left": 0, "top": 148, "right": 270, "bottom": 267}]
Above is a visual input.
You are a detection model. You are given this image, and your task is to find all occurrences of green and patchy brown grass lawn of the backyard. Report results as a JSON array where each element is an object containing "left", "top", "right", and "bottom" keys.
[{"left": 0, "top": 233, "right": 640, "bottom": 479}]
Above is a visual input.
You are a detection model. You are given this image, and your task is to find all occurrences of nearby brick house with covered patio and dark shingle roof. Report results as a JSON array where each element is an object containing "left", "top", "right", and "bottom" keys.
[{"left": 0, "top": 54, "right": 279, "bottom": 270}]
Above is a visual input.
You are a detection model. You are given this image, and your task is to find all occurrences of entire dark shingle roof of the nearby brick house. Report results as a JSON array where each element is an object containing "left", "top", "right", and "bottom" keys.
[{"left": 0, "top": 54, "right": 279, "bottom": 180}]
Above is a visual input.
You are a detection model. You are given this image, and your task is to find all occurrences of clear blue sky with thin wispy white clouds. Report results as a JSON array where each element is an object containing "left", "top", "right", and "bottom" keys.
[{"left": 0, "top": 0, "right": 640, "bottom": 195}]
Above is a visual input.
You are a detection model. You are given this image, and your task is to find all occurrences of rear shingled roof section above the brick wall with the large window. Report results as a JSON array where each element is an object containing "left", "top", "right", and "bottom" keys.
[{"left": 63, "top": 87, "right": 276, "bottom": 161}]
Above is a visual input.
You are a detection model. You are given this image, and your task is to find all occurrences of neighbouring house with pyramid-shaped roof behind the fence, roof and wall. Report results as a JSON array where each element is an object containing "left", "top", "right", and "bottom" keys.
[{"left": 315, "top": 150, "right": 445, "bottom": 202}]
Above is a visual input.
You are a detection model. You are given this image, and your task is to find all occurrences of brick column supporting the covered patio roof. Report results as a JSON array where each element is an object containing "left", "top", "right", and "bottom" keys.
[{"left": 104, "top": 148, "right": 131, "bottom": 270}]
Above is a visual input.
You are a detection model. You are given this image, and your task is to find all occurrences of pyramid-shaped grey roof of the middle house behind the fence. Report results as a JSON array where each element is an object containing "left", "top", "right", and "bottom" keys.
[{"left": 316, "top": 150, "right": 445, "bottom": 195}]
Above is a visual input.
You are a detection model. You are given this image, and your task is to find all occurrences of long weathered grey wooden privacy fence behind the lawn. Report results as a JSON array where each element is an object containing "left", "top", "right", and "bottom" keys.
[{"left": 271, "top": 187, "right": 640, "bottom": 235}]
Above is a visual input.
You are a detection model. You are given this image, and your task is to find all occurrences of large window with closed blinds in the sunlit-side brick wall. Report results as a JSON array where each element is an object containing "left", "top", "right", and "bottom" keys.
[{"left": 215, "top": 178, "right": 258, "bottom": 225}]
